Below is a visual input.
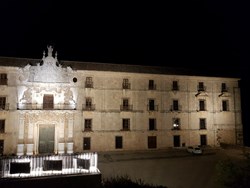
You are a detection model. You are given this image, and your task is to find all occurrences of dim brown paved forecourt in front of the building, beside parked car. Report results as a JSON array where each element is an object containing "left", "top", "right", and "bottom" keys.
[{"left": 98, "top": 148, "right": 247, "bottom": 188}]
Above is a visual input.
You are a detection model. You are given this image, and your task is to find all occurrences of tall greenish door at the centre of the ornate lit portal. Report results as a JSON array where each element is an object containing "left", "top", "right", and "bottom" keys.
[{"left": 38, "top": 125, "right": 55, "bottom": 154}]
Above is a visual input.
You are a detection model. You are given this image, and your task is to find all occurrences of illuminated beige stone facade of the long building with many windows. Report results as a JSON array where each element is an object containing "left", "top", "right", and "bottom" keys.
[{"left": 0, "top": 47, "right": 243, "bottom": 155}]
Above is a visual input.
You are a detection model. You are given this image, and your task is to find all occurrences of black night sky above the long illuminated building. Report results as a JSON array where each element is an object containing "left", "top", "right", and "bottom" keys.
[{"left": 0, "top": 0, "right": 250, "bottom": 144}]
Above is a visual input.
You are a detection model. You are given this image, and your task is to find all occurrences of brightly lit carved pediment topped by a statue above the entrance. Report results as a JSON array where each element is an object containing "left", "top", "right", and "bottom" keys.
[{"left": 19, "top": 46, "right": 72, "bottom": 83}]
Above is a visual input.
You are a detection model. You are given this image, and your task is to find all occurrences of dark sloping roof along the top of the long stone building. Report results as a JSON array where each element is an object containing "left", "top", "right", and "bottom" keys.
[{"left": 0, "top": 56, "right": 240, "bottom": 79}]
